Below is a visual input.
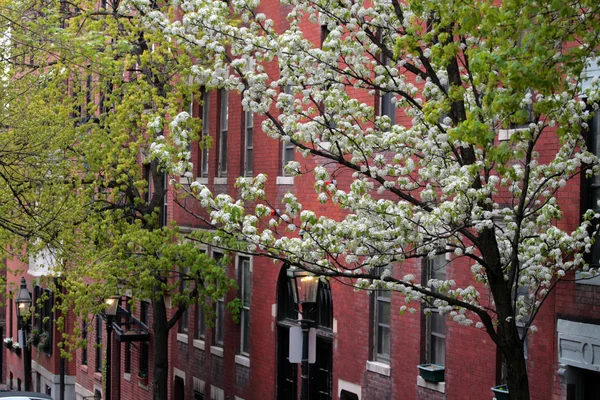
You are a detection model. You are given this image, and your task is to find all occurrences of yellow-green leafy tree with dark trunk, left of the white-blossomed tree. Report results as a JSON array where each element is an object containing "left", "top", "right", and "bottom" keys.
[{"left": 0, "top": 0, "right": 235, "bottom": 399}]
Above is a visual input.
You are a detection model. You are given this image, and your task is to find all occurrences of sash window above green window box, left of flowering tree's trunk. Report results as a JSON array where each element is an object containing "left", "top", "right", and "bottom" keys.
[{"left": 425, "top": 255, "right": 446, "bottom": 365}]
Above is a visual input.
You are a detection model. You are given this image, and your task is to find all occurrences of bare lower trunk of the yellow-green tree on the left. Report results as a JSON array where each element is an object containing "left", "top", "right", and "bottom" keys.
[{"left": 152, "top": 297, "right": 169, "bottom": 400}]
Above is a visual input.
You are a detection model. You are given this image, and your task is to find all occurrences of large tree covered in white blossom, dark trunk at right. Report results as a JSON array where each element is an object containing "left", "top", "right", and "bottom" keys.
[{"left": 129, "top": 0, "right": 600, "bottom": 399}]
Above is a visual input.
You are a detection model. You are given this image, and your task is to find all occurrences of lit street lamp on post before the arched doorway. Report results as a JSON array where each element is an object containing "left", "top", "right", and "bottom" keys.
[{"left": 287, "top": 267, "right": 319, "bottom": 400}]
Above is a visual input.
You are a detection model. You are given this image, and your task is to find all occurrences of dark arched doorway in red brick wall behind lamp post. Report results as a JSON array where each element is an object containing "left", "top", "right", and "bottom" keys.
[{"left": 277, "top": 266, "right": 333, "bottom": 400}]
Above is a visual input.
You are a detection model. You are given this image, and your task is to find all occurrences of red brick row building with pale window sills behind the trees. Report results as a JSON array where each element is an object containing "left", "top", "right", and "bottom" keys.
[{"left": 3, "top": 0, "right": 600, "bottom": 400}]
